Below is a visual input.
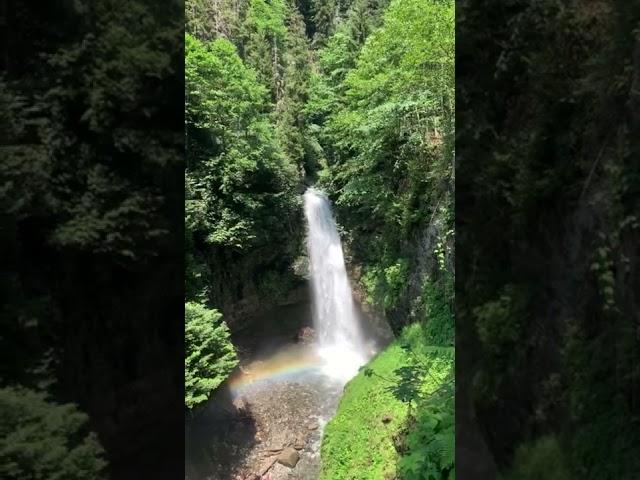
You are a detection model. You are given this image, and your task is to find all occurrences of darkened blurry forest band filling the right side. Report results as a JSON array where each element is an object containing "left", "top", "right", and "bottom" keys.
[{"left": 456, "top": 0, "right": 640, "bottom": 480}]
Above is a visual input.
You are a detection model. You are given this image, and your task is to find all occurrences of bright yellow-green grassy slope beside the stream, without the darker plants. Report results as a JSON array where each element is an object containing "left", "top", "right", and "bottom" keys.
[{"left": 320, "top": 325, "right": 445, "bottom": 480}]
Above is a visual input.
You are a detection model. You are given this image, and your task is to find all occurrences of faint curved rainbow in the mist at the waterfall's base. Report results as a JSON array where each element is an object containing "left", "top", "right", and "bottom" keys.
[{"left": 228, "top": 350, "right": 322, "bottom": 396}]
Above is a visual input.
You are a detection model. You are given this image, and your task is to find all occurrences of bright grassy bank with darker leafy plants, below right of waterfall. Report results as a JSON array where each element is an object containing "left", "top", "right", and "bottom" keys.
[{"left": 321, "top": 324, "right": 454, "bottom": 480}]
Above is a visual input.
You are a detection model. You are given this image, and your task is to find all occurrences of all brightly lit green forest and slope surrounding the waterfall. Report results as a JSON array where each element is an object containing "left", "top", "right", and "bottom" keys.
[{"left": 185, "top": 0, "right": 455, "bottom": 480}]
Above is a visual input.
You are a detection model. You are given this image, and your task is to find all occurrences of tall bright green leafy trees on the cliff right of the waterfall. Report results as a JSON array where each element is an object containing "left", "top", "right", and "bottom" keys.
[{"left": 305, "top": 0, "right": 454, "bottom": 336}]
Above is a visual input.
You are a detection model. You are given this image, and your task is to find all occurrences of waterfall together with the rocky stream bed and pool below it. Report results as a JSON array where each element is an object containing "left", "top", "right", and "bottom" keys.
[{"left": 185, "top": 188, "right": 387, "bottom": 480}]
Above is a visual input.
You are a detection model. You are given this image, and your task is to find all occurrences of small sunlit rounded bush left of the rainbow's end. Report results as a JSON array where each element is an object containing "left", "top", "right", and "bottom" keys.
[{"left": 184, "top": 302, "right": 238, "bottom": 409}]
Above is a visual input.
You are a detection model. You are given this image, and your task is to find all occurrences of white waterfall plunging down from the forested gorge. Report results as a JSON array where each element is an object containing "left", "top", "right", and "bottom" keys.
[{"left": 304, "top": 188, "right": 368, "bottom": 381}]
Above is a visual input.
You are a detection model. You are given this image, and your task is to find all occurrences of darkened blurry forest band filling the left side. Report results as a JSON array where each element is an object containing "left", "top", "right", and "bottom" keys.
[{"left": 0, "top": 0, "right": 183, "bottom": 480}]
